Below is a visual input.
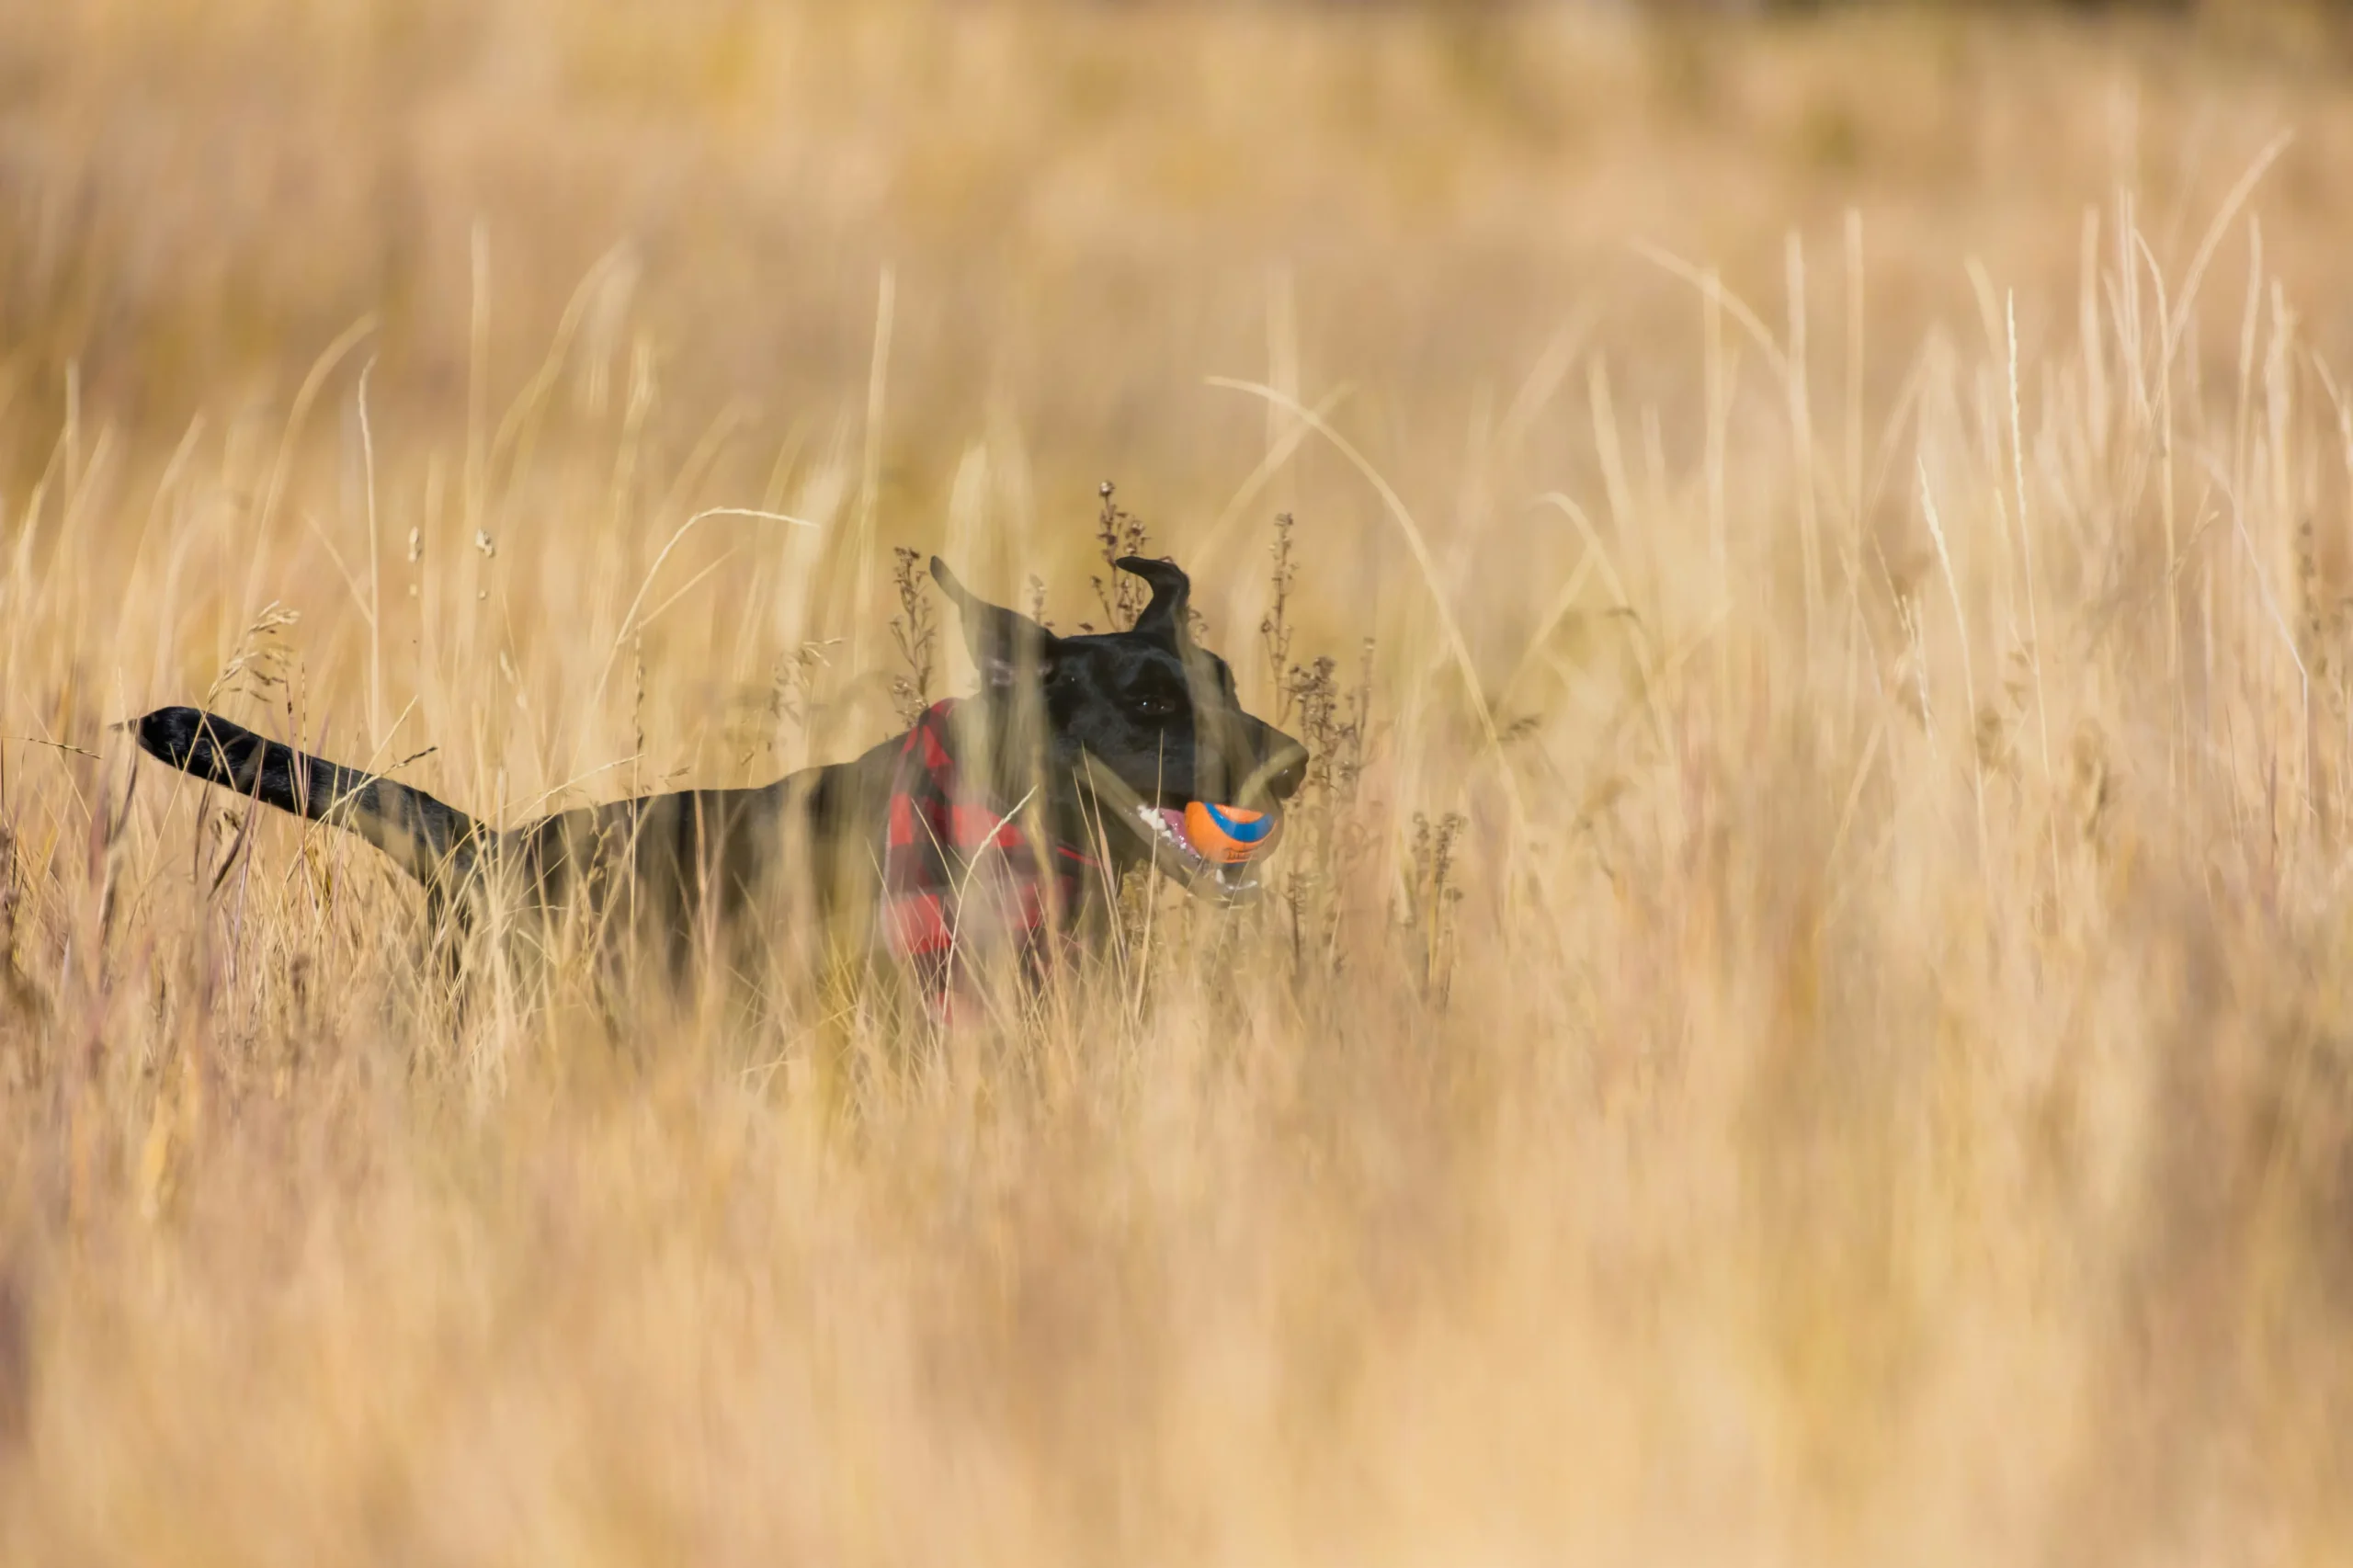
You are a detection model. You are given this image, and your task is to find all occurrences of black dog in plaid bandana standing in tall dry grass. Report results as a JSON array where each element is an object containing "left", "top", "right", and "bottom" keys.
[{"left": 134, "top": 556, "right": 1308, "bottom": 983}]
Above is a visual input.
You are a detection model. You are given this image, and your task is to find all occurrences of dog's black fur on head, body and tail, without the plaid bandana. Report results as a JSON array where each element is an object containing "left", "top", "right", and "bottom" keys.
[{"left": 134, "top": 556, "right": 1306, "bottom": 956}]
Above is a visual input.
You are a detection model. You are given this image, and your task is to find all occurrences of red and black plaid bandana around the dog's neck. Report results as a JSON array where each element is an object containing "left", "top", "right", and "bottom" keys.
[{"left": 882, "top": 697, "right": 1097, "bottom": 1010}]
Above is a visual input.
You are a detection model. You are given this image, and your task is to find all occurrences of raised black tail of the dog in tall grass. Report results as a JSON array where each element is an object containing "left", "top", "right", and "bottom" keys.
[{"left": 131, "top": 709, "right": 492, "bottom": 888}]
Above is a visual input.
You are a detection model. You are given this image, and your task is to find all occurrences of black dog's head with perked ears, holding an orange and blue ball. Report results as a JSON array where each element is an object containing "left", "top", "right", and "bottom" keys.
[{"left": 932, "top": 556, "right": 1308, "bottom": 897}]
